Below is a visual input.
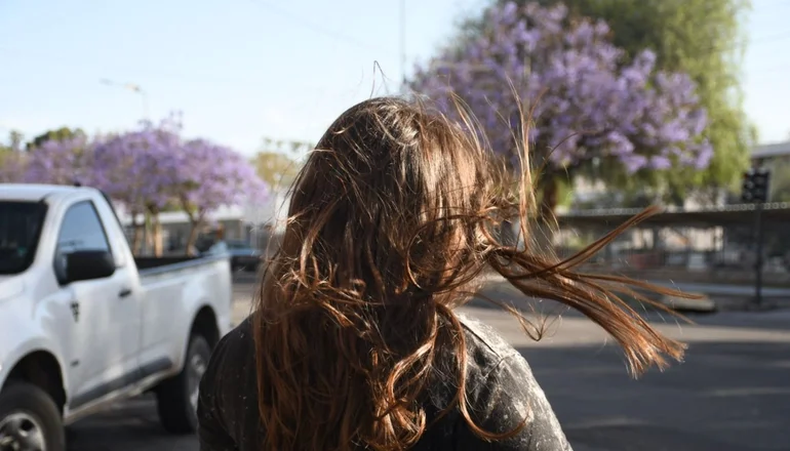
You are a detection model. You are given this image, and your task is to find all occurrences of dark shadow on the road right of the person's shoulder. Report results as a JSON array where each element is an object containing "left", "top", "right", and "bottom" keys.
[{"left": 521, "top": 342, "right": 790, "bottom": 451}]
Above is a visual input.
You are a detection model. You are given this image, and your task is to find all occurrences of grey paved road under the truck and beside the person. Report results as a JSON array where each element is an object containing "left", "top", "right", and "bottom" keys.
[{"left": 69, "top": 285, "right": 790, "bottom": 451}]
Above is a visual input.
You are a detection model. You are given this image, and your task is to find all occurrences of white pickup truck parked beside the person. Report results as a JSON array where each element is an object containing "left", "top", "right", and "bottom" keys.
[{"left": 0, "top": 184, "right": 232, "bottom": 451}]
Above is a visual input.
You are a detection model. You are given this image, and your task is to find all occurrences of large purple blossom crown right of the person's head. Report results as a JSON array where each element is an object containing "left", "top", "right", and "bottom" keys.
[{"left": 411, "top": 2, "right": 712, "bottom": 178}]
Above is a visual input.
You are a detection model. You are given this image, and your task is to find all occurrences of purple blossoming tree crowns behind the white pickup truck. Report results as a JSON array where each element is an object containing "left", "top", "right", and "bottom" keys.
[{"left": 15, "top": 114, "right": 268, "bottom": 222}]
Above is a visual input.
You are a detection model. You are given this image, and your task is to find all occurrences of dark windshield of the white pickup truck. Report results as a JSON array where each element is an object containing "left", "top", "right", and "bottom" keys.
[{"left": 0, "top": 201, "right": 47, "bottom": 274}]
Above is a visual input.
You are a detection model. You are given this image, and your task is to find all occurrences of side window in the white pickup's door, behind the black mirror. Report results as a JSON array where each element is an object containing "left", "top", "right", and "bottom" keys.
[{"left": 54, "top": 201, "right": 112, "bottom": 281}]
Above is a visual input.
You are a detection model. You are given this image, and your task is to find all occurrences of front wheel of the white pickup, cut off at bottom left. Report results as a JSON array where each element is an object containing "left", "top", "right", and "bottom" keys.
[{"left": 0, "top": 382, "right": 66, "bottom": 451}]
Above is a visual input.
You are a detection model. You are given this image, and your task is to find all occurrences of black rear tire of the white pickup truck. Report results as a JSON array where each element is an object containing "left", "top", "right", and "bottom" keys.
[{"left": 156, "top": 335, "right": 211, "bottom": 434}]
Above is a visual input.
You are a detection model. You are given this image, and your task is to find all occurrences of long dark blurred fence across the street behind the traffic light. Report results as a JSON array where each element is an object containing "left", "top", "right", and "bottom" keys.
[{"left": 555, "top": 204, "right": 790, "bottom": 286}]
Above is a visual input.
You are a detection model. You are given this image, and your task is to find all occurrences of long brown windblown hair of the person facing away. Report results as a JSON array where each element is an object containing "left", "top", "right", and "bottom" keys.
[{"left": 253, "top": 98, "right": 683, "bottom": 451}]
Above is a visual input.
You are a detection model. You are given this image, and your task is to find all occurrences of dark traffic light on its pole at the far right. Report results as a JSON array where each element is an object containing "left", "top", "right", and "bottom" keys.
[{"left": 741, "top": 168, "right": 771, "bottom": 307}]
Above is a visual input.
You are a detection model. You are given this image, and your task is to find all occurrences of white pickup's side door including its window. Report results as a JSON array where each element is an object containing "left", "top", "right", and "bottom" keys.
[{"left": 53, "top": 200, "right": 140, "bottom": 409}]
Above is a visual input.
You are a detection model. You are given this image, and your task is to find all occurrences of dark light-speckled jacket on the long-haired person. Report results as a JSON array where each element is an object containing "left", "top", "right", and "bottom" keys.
[{"left": 198, "top": 315, "right": 571, "bottom": 451}]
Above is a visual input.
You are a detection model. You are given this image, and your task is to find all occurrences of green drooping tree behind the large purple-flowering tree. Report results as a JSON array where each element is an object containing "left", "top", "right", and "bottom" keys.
[{"left": 468, "top": 0, "right": 756, "bottom": 203}]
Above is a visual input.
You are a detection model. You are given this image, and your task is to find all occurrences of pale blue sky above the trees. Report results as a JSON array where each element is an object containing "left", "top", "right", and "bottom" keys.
[{"left": 0, "top": 0, "right": 790, "bottom": 159}]
